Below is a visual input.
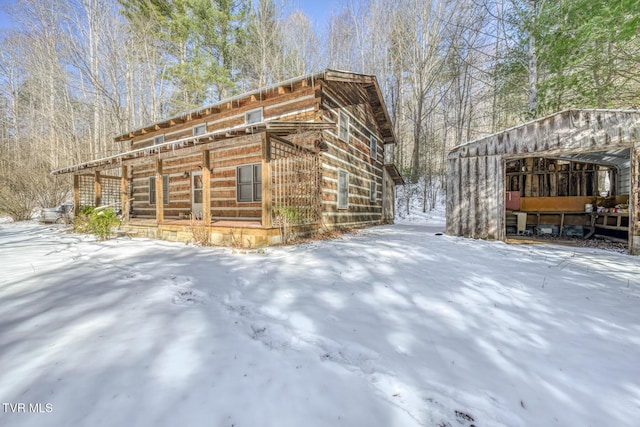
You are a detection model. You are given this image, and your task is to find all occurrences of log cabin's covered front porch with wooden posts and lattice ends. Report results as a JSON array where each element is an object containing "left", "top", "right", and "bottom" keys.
[{"left": 63, "top": 132, "right": 322, "bottom": 247}]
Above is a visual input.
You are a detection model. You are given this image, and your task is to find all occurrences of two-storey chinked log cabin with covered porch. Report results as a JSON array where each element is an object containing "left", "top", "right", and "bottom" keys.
[{"left": 52, "top": 70, "right": 403, "bottom": 247}]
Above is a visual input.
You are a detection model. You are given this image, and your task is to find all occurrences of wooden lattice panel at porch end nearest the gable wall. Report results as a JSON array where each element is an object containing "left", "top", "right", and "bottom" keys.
[{"left": 271, "top": 139, "right": 321, "bottom": 227}]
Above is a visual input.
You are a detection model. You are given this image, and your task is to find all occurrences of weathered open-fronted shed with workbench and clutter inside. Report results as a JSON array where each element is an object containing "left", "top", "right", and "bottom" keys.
[{"left": 447, "top": 109, "right": 640, "bottom": 255}]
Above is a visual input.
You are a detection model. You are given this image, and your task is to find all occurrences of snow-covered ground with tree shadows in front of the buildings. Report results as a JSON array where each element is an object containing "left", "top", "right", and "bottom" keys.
[{"left": 0, "top": 214, "right": 640, "bottom": 427}]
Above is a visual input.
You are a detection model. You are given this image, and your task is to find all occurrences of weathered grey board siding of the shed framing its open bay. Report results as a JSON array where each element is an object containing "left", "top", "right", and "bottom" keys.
[{"left": 447, "top": 110, "right": 640, "bottom": 253}]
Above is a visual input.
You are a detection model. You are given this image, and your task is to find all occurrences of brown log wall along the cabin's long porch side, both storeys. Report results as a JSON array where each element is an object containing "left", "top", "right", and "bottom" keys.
[{"left": 130, "top": 86, "right": 319, "bottom": 220}]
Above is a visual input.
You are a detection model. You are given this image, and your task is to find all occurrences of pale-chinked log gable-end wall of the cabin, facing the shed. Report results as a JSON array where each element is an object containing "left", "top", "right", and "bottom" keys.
[{"left": 321, "top": 82, "right": 384, "bottom": 228}]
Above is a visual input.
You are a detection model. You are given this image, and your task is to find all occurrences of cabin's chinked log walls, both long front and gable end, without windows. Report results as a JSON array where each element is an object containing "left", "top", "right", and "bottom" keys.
[{"left": 122, "top": 76, "right": 395, "bottom": 231}]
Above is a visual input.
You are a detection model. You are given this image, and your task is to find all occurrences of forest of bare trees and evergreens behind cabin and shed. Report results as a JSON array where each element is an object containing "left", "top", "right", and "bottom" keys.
[{"left": 0, "top": 0, "right": 640, "bottom": 219}]
